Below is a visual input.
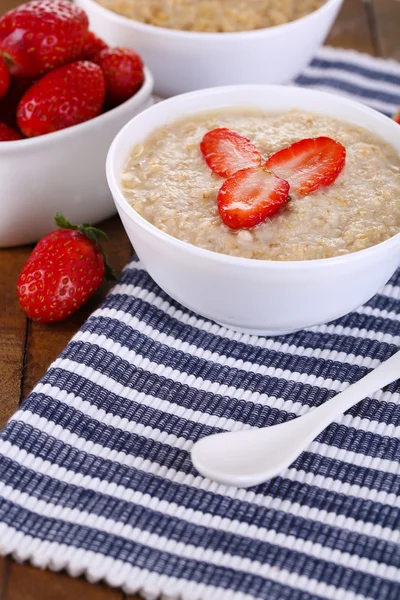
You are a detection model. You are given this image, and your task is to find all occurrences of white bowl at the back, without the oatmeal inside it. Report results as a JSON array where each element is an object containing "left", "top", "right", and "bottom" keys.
[{"left": 75, "top": 0, "right": 342, "bottom": 97}]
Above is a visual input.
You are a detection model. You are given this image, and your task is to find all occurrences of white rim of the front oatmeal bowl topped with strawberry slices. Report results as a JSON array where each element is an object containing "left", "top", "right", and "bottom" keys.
[{"left": 106, "top": 84, "right": 400, "bottom": 270}]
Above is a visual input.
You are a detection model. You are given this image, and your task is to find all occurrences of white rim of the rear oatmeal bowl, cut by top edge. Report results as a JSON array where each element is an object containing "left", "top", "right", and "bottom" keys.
[{"left": 76, "top": 0, "right": 343, "bottom": 42}]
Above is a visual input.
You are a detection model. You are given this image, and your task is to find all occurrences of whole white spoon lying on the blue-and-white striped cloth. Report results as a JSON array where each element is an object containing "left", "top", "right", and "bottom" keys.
[{"left": 192, "top": 351, "right": 400, "bottom": 487}]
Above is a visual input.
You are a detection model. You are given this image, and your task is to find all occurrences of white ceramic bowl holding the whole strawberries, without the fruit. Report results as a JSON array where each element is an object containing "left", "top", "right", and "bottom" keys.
[{"left": 0, "top": 69, "right": 153, "bottom": 247}]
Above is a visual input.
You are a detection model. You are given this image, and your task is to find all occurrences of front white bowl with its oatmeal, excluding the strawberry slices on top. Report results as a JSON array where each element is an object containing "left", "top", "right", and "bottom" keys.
[{"left": 107, "top": 86, "right": 400, "bottom": 335}]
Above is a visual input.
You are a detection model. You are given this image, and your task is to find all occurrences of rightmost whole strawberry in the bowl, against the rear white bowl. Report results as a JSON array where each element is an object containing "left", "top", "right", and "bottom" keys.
[{"left": 96, "top": 48, "right": 144, "bottom": 106}]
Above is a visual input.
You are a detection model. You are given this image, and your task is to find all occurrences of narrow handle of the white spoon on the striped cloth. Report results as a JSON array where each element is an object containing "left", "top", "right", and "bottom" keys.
[{"left": 299, "top": 351, "right": 400, "bottom": 435}]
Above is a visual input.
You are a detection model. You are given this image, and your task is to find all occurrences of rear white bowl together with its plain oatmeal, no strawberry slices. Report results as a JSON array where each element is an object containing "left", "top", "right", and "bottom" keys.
[{"left": 76, "top": 0, "right": 342, "bottom": 97}]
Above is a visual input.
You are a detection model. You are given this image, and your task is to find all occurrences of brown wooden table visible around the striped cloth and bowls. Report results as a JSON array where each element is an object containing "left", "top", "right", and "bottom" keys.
[{"left": 0, "top": 0, "right": 400, "bottom": 600}]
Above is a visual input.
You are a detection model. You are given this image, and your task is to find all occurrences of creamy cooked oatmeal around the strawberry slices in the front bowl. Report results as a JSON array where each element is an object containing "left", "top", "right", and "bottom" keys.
[{"left": 122, "top": 110, "right": 400, "bottom": 260}]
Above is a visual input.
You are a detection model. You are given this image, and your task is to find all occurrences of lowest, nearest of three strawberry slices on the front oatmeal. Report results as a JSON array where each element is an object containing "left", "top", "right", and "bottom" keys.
[{"left": 217, "top": 167, "right": 289, "bottom": 229}]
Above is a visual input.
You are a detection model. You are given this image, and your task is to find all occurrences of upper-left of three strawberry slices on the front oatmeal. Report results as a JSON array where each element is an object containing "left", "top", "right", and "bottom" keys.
[{"left": 200, "top": 127, "right": 261, "bottom": 177}]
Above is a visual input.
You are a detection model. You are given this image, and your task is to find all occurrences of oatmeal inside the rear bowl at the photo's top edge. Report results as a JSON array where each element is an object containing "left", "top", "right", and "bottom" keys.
[{"left": 97, "top": 0, "right": 324, "bottom": 32}]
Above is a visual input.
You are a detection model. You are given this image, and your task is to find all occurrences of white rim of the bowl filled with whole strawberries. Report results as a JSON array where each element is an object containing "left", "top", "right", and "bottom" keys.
[{"left": 0, "top": 66, "right": 154, "bottom": 155}]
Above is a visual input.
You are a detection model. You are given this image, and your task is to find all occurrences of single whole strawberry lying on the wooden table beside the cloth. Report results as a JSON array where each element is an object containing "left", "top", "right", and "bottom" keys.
[{"left": 17, "top": 214, "right": 115, "bottom": 323}]
